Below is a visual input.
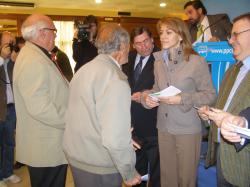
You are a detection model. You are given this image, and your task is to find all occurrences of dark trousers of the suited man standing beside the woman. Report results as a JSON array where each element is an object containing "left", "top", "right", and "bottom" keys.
[{"left": 135, "top": 137, "right": 161, "bottom": 187}]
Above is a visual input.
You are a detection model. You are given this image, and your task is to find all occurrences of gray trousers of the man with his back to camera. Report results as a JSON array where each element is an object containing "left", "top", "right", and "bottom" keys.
[{"left": 70, "top": 166, "right": 122, "bottom": 187}]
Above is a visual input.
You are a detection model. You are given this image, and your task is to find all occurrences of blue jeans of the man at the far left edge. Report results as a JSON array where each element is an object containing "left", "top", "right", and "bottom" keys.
[{"left": 0, "top": 104, "right": 16, "bottom": 180}]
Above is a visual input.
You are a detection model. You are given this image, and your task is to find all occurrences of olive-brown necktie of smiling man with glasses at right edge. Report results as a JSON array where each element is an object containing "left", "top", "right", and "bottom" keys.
[{"left": 216, "top": 62, "right": 243, "bottom": 109}]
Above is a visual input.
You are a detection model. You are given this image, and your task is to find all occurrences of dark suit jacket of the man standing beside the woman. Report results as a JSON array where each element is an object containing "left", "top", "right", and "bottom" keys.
[{"left": 123, "top": 47, "right": 159, "bottom": 141}]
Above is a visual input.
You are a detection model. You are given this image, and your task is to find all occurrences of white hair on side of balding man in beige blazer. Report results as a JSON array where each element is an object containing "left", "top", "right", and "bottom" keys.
[{"left": 21, "top": 20, "right": 47, "bottom": 41}]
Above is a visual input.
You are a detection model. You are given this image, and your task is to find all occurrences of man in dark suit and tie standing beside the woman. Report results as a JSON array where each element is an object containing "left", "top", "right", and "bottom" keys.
[{"left": 123, "top": 27, "right": 160, "bottom": 187}]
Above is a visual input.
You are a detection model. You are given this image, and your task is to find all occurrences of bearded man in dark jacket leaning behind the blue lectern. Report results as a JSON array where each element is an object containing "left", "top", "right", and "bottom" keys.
[{"left": 184, "top": 0, "right": 232, "bottom": 42}]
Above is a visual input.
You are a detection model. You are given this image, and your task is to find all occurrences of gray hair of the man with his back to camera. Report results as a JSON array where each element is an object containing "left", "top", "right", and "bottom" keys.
[{"left": 95, "top": 24, "right": 130, "bottom": 54}]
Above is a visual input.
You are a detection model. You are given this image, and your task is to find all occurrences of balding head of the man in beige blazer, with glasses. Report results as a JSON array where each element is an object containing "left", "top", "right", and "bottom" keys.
[{"left": 21, "top": 14, "right": 56, "bottom": 51}]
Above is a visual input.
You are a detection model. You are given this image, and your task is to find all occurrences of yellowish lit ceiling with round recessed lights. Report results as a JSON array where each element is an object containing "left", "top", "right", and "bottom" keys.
[{"left": 1, "top": 0, "right": 188, "bottom": 18}]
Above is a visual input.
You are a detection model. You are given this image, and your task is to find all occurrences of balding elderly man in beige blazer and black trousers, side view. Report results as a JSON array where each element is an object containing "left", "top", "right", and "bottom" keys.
[{"left": 13, "top": 14, "right": 68, "bottom": 187}]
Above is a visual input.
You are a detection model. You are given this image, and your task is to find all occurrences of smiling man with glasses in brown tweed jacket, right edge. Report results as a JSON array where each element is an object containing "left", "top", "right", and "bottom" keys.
[{"left": 199, "top": 13, "right": 250, "bottom": 187}]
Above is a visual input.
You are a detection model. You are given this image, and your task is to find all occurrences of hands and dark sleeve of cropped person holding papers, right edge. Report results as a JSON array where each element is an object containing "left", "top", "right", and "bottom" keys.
[{"left": 221, "top": 107, "right": 250, "bottom": 151}]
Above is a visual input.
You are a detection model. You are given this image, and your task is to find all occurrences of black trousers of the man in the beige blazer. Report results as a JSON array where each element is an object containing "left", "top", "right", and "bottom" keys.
[{"left": 28, "top": 164, "right": 68, "bottom": 187}]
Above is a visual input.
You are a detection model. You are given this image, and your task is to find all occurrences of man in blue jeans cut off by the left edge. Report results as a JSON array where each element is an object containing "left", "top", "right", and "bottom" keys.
[{"left": 0, "top": 32, "right": 21, "bottom": 187}]
